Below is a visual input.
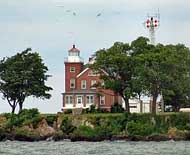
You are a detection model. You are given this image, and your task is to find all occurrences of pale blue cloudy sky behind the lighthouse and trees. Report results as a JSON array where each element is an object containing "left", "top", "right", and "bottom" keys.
[{"left": 0, "top": 0, "right": 190, "bottom": 113}]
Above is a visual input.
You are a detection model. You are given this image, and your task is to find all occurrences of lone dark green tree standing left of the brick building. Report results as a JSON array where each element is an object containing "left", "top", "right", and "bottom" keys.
[{"left": 0, "top": 48, "right": 52, "bottom": 113}]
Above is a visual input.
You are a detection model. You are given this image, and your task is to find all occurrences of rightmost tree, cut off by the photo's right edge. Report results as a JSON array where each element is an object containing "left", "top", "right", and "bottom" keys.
[{"left": 163, "top": 44, "right": 190, "bottom": 111}]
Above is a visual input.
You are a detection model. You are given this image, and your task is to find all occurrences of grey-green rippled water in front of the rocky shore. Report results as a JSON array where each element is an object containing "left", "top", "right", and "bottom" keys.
[{"left": 0, "top": 141, "right": 190, "bottom": 155}]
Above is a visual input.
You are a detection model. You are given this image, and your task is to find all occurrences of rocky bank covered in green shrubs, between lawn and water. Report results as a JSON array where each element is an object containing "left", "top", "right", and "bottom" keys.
[{"left": 0, "top": 109, "right": 190, "bottom": 142}]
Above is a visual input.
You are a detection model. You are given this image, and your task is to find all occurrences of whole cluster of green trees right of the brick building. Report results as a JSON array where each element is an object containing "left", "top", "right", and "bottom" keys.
[{"left": 91, "top": 37, "right": 190, "bottom": 113}]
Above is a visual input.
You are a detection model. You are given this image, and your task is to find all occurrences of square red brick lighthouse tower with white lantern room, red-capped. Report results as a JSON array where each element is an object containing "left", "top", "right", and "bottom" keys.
[{"left": 65, "top": 45, "right": 83, "bottom": 91}]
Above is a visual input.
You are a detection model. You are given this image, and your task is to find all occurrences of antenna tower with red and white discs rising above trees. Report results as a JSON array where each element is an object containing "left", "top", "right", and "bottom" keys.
[{"left": 144, "top": 10, "right": 160, "bottom": 45}]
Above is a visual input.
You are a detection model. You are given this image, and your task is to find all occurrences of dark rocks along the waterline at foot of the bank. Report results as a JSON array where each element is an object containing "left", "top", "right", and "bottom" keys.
[{"left": 0, "top": 130, "right": 190, "bottom": 142}]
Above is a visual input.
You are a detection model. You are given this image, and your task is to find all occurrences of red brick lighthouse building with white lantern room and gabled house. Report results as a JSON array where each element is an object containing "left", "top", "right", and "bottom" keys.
[{"left": 62, "top": 45, "right": 122, "bottom": 111}]
